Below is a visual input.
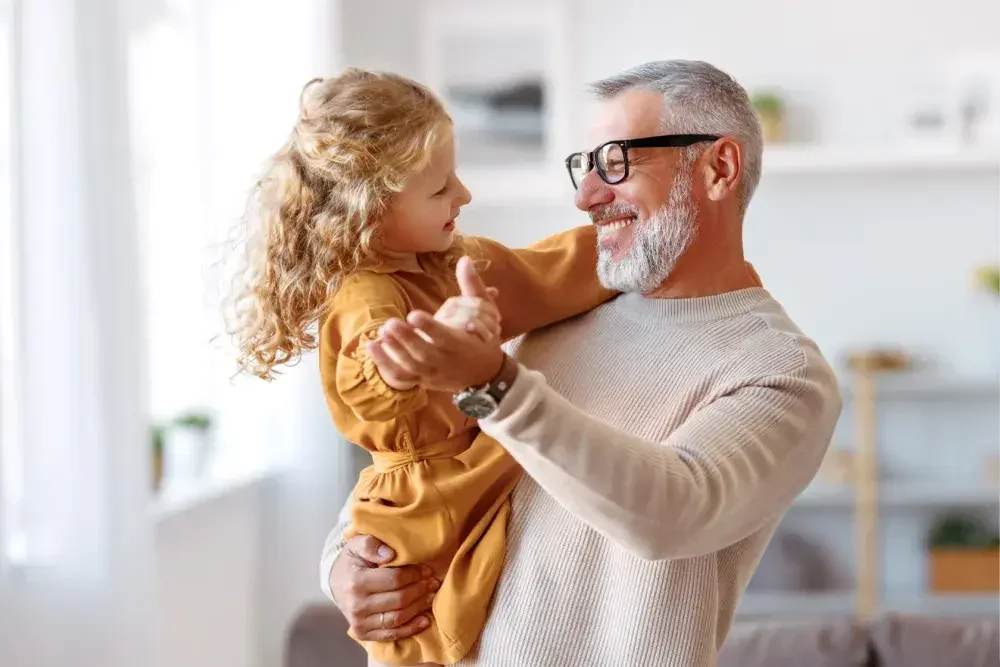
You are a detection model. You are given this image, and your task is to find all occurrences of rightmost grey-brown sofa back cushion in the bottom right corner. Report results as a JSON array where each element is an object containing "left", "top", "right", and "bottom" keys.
[{"left": 870, "top": 614, "right": 1000, "bottom": 667}]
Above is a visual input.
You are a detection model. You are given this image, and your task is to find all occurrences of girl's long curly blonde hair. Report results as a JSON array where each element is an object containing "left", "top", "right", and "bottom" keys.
[{"left": 224, "top": 68, "right": 462, "bottom": 379}]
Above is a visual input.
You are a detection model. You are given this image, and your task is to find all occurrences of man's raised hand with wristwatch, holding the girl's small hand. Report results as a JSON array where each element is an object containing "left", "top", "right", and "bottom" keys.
[{"left": 368, "top": 257, "right": 503, "bottom": 393}]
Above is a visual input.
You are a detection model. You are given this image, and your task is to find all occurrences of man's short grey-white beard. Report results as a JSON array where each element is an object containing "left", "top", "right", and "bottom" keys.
[{"left": 597, "top": 169, "right": 698, "bottom": 293}]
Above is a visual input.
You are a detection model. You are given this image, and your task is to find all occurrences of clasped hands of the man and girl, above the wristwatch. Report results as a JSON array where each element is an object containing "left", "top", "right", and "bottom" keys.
[{"left": 367, "top": 257, "right": 503, "bottom": 393}]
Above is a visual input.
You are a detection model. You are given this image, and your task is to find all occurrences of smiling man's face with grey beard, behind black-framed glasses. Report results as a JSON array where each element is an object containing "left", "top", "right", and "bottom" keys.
[{"left": 576, "top": 90, "right": 697, "bottom": 292}]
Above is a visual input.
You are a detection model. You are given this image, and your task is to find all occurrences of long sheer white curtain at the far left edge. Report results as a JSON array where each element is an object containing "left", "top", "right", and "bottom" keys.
[{"left": 0, "top": 0, "right": 155, "bottom": 667}]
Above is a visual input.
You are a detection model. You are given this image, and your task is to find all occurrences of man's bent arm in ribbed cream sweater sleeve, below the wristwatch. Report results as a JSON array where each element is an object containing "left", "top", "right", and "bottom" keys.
[{"left": 480, "top": 368, "right": 840, "bottom": 559}]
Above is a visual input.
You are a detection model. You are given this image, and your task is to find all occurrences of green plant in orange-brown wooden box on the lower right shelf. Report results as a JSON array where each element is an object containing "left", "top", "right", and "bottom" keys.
[{"left": 927, "top": 514, "right": 1000, "bottom": 593}]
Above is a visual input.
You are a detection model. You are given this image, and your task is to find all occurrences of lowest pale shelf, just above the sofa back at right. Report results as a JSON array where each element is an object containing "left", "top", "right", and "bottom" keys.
[{"left": 736, "top": 591, "right": 1000, "bottom": 618}]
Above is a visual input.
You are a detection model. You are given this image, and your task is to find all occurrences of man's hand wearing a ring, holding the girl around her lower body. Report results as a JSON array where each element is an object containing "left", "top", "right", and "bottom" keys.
[{"left": 330, "top": 535, "right": 440, "bottom": 641}]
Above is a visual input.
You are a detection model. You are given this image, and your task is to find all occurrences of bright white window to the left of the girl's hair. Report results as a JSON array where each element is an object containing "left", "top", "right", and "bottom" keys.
[{"left": 128, "top": 0, "right": 315, "bottom": 480}]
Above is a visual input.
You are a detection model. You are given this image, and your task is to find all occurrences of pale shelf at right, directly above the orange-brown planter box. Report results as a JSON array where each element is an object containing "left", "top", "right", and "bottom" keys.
[{"left": 793, "top": 480, "right": 1000, "bottom": 508}]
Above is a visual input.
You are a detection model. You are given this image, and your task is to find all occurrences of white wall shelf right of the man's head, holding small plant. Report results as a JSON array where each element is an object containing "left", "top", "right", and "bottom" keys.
[{"left": 763, "top": 144, "right": 1000, "bottom": 174}]
